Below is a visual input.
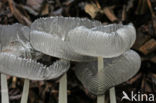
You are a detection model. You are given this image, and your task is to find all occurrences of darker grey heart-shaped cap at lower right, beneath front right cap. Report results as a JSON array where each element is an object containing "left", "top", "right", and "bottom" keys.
[{"left": 74, "top": 50, "right": 141, "bottom": 95}]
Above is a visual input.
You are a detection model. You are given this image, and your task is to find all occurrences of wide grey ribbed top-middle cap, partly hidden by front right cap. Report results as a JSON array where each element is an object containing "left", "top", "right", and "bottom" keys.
[{"left": 30, "top": 17, "right": 101, "bottom": 61}]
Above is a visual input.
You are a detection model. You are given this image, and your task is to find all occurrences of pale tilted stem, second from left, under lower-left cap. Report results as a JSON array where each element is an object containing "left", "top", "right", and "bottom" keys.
[{"left": 21, "top": 79, "right": 30, "bottom": 103}]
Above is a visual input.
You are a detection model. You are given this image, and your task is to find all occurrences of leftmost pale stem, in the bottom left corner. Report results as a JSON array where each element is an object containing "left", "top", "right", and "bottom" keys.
[{"left": 1, "top": 74, "right": 9, "bottom": 103}]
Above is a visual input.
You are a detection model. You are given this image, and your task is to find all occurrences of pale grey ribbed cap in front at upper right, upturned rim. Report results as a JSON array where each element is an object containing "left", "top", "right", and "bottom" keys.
[{"left": 68, "top": 24, "right": 136, "bottom": 58}]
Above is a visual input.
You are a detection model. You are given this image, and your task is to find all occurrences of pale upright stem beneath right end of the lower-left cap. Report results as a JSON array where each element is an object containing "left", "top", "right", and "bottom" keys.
[{"left": 59, "top": 73, "right": 67, "bottom": 103}]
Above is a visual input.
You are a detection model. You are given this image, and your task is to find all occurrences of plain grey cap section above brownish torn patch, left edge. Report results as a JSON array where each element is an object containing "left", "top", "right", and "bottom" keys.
[{"left": 0, "top": 23, "right": 30, "bottom": 48}]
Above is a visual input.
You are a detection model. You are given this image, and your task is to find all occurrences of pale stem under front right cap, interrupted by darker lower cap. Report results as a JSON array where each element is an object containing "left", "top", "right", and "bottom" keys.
[{"left": 97, "top": 57, "right": 105, "bottom": 103}]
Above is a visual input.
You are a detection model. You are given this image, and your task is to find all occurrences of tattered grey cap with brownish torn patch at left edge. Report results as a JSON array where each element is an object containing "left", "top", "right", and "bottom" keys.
[{"left": 0, "top": 23, "right": 31, "bottom": 56}]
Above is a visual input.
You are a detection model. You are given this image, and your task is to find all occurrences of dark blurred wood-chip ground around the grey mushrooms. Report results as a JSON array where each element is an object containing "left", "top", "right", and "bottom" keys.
[{"left": 0, "top": 0, "right": 156, "bottom": 103}]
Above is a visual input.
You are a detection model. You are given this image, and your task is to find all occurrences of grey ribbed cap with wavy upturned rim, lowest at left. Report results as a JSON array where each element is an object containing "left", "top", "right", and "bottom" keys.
[{"left": 0, "top": 53, "right": 70, "bottom": 80}]
